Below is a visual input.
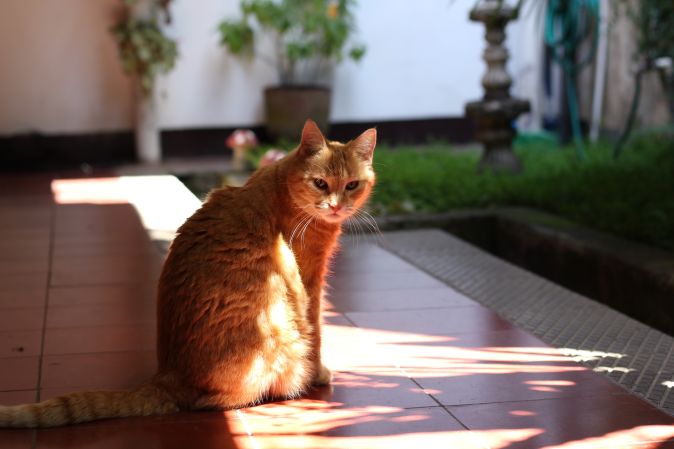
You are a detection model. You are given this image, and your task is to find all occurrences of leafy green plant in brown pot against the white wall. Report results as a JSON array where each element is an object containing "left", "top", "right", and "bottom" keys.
[{"left": 218, "top": 0, "right": 365, "bottom": 139}]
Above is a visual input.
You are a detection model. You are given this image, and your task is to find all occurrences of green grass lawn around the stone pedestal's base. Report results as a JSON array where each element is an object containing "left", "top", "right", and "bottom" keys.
[{"left": 371, "top": 132, "right": 674, "bottom": 250}]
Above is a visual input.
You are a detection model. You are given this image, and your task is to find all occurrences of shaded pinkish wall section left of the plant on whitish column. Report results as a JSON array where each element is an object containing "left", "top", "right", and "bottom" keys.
[{"left": 0, "top": 0, "right": 132, "bottom": 134}]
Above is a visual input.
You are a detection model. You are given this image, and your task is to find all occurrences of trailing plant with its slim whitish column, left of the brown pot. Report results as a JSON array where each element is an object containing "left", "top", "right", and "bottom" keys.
[{"left": 111, "top": 0, "right": 178, "bottom": 163}]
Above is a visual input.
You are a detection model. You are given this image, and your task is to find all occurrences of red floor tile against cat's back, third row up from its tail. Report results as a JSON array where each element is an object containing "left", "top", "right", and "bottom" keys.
[{"left": 47, "top": 301, "right": 157, "bottom": 328}]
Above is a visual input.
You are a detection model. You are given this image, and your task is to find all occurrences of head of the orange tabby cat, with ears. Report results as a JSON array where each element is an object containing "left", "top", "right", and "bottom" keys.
[{"left": 288, "top": 120, "right": 377, "bottom": 223}]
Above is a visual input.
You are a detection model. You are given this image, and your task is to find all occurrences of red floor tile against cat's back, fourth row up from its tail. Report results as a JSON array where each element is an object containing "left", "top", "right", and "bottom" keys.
[{"left": 49, "top": 282, "right": 156, "bottom": 307}]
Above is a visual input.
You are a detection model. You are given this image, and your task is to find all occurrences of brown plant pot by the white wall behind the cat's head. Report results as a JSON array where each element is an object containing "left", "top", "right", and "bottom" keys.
[{"left": 264, "top": 86, "right": 331, "bottom": 142}]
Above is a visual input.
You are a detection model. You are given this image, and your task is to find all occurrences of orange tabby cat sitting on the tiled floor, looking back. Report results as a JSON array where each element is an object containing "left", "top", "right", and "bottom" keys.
[{"left": 0, "top": 120, "right": 376, "bottom": 427}]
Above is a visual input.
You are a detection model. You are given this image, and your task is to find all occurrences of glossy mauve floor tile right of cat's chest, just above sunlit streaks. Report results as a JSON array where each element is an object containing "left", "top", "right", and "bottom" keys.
[{"left": 328, "top": 287, "right": 477, "bottom": 312}]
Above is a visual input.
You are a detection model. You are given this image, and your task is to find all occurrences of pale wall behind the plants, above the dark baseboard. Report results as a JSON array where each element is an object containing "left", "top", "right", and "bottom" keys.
[{"left": 0, "top": 0, "right": 540, "bottom": 134}]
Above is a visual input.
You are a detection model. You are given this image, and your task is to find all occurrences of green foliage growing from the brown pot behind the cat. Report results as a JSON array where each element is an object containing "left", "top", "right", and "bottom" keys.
[{"left": 218, "top": 0, "right": 365, "bottom": 85}]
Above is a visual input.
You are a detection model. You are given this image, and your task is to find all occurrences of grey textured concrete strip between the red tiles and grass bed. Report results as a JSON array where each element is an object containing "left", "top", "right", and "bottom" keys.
[{"left": 378, "top": 230, "right": 674, "bottom": 415}]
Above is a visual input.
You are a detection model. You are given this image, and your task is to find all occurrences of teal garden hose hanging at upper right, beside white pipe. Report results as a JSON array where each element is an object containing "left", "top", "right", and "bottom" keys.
[{"left": 545, "top": 0, "right": 599, "bottom": 159}]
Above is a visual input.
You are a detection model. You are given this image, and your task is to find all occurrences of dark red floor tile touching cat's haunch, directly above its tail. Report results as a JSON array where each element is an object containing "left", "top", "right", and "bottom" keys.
[{"left": 41, "top": 351, "right": 157, "bottom": 390}]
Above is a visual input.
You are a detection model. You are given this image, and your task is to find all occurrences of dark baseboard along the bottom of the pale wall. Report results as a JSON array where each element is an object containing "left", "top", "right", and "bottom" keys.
[{"left": 0, "top": 117, "right": 474, "bottom": 172}]
